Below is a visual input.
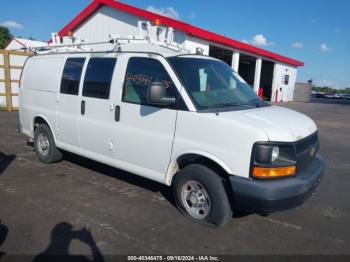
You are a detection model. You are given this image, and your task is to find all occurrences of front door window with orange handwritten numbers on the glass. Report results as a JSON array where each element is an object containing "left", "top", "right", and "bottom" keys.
[{"left": 122, "top": 57, "right": 177, "bottom": 105}]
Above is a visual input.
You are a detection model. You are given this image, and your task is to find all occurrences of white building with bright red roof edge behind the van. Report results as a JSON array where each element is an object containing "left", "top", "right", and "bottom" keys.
[{"left": 53, "top": 0, "right": 304, "bottom": 101}]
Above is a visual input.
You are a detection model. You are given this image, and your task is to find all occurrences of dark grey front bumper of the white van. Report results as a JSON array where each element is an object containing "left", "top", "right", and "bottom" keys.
[{"left": 230, "top": 156, "right": 325, "bottom": 213}]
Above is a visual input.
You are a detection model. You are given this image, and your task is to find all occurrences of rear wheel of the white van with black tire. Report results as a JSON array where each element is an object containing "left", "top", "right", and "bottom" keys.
[{"left": 34, "top": 124, "right": 63, "bottom": 164}]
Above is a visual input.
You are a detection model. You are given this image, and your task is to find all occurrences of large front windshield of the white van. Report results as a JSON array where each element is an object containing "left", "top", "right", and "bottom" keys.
[{"left": 168, "top": 57, "right": 268, "bottom": 110}]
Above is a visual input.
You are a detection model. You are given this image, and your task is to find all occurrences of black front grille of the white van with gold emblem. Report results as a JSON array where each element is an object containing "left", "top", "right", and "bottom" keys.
[{"left": 295, "top": 132, "right": 320, "bottom": 172}]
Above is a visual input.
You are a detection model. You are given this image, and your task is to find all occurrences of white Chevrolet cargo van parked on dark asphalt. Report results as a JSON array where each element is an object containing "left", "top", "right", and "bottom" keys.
[{"left": 20, "top": 39, "right": 325, "bottom": 226}]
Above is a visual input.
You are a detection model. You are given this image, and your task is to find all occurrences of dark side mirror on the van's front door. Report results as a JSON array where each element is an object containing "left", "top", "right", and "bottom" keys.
[{"left": 147, "top": 82, "right": 176, "bottom": 106}]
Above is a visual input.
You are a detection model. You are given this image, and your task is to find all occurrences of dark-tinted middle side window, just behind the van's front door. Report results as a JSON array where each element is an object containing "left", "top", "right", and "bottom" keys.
[{"left": 83, "top": 58, "right": 117, "bottom": 99}]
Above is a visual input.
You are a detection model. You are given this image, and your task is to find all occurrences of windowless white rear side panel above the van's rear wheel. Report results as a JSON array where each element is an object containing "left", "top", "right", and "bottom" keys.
[{"left": 19, "top": 56, "right": 64, "bottom": 137}]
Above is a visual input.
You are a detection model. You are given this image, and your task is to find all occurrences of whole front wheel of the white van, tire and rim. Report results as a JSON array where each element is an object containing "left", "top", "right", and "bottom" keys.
[{"left": 173, "top": 164, "right": 232, "bottom": 227}]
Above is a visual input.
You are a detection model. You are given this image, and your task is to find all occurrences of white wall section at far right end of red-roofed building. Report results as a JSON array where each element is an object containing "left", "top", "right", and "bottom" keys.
[{"left": 272, "top": 63, "right": 297, "bottom": 102}]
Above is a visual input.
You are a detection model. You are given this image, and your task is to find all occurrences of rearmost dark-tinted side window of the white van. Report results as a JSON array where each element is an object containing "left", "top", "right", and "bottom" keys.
[{"left": 60, "top": 58, "right": 85, "bottom": 95}]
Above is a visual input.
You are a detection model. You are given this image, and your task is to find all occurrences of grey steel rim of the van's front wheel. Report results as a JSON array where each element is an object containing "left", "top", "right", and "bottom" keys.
[{"left": 181, "top": 180, "right": 211, "bottom": 219}]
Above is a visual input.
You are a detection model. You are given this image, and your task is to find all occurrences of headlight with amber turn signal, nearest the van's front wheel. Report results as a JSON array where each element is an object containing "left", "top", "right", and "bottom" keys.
[{"left": 252, "top": 143, "right": 296, "bottom": 178}]
